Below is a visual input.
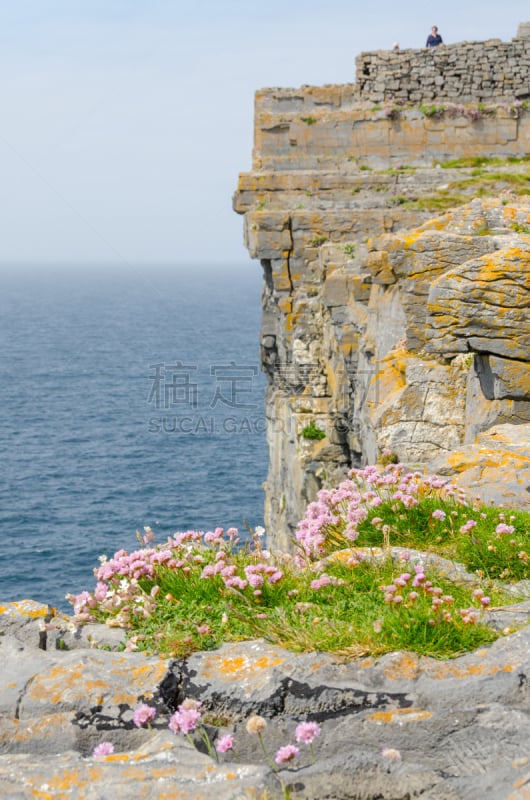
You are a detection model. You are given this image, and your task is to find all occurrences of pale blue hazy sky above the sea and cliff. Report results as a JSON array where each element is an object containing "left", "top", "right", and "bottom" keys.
[{"left": 0, "top": 0, "right": 530, "bottom": 266}]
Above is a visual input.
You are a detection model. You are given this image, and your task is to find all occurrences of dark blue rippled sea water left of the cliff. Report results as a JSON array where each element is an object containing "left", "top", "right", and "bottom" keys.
[{"left": 0, "top": 263, "right": 267, "bottom": 609}]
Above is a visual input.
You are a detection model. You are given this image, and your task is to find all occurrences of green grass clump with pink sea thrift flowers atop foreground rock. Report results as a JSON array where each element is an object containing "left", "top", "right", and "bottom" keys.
[{"left": 69, "top": 464, "right": 530, "bottom": 658}]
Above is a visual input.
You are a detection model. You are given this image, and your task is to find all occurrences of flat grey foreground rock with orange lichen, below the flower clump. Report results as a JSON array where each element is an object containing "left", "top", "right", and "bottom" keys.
[{"left": 0, "top": 603, "right": 530, "bottom": 800}]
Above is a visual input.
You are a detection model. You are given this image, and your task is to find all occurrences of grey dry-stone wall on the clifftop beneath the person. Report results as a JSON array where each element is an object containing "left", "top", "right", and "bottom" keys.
[{"left": 355, "top": 22, "right": 530, "bottom": 103}]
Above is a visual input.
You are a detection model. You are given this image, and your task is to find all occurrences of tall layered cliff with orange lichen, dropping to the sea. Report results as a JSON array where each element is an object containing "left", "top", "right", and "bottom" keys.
[{"left": 234, "top": 26, "right": 530, "bottom": 547}]
